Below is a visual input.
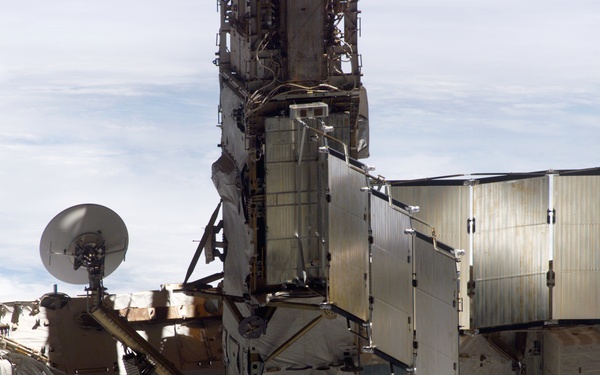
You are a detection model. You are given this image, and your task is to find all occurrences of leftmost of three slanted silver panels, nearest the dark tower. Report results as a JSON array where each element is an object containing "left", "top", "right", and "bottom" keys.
[{"left": 327, "top": 156, "right": 369, "bottom": 321}]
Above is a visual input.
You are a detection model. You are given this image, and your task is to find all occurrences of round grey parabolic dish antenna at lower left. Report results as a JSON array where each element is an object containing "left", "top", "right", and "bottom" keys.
[{"left": 40, "top": 204, "right": 129, "bottom": 284}]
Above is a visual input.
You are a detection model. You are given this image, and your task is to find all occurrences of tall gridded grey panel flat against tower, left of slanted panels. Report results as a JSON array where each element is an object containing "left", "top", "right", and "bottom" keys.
[{"left": 265, "top": 117, "right": 320, "bottom": 284}]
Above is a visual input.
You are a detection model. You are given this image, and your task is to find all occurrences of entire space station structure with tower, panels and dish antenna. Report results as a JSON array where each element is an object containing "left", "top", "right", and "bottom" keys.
[{"left": 0, "top": 0, "right": 600, "bottom": 375}]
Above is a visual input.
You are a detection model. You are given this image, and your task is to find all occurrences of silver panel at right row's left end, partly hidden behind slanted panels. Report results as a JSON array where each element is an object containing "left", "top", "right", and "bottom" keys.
[{"left": 392, "top": 185, "right": 471, "bottom": 329}]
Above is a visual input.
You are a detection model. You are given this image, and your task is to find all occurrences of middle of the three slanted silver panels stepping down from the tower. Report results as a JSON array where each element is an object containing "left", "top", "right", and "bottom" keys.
[{"left": 371, "top": 196, "right": 414, "bottom": 364}]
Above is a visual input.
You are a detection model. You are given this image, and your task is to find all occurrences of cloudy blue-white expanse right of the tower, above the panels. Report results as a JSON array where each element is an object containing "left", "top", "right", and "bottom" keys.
[{"left": 359, "top": 0, "right": 600, "bottom": 179}]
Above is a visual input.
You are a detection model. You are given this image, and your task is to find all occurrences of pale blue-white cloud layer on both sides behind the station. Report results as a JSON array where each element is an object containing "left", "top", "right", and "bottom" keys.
[{"left": 0, "top": 0, "right": 600, "bottom": 301}]
